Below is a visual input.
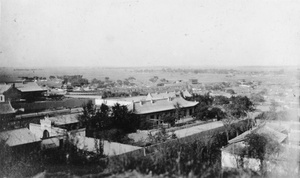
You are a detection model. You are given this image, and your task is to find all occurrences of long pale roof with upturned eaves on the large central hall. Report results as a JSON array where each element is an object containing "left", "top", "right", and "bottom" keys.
[{"left": 129, "top": 97, "right": 198, "bottom": 114}]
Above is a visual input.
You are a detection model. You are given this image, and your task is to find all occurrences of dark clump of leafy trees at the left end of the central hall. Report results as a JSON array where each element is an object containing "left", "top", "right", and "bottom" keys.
[{"left": 79, "top": 102, "right": 141, "bottom": 142}]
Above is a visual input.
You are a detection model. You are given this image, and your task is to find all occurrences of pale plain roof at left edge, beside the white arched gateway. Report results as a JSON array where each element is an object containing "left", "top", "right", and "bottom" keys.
[{"left": 0, "top": 128, "right": 41, "bottom": 146}]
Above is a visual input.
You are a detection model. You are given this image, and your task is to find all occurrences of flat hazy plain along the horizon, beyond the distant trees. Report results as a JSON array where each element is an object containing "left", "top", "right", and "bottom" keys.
[{"left": 0, "top": 67, "right": 296, "bottom": 84}]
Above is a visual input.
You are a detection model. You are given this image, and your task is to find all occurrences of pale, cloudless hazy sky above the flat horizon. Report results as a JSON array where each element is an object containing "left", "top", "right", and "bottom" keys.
[{"left": 0, "top": 0, "right": 300, "bottom": 67}]
